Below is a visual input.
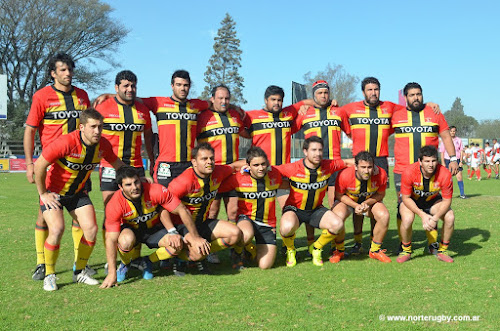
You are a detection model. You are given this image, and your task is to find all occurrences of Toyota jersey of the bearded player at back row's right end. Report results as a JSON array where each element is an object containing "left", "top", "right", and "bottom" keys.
[{"left": 392, "top": 106, "right": 448, "bottom": 174}]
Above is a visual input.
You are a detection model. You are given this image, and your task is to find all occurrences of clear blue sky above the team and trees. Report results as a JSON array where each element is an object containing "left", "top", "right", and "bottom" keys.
[{"left": 91, "top": 0, "right": 500, "bottom": 120}]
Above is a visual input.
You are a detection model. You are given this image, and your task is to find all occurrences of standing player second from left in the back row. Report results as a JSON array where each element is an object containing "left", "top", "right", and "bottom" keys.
[{"left": 96, "top": 70, "right": 154, "bottom": 257}]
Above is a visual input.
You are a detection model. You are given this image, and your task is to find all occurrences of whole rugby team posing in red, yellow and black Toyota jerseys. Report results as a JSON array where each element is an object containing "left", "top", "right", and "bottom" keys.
[{"left": 24, "top": 53, "right": 474, "bottom": 291}]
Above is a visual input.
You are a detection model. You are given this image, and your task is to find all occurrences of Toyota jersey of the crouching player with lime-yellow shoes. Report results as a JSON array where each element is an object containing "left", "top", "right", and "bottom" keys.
[{"left": 276, "top": 159, "right": 345, "bottom": 210}]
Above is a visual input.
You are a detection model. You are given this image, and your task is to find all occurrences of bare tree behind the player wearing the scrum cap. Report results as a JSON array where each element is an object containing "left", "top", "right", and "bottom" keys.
[{"left": 304, "top": 63, "right": 359, "bottom": 106}]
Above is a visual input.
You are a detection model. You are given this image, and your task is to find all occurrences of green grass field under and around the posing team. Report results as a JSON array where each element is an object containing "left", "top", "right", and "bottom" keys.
[{"left": 0, "top": 173, "right": 500, "bottom": 330}]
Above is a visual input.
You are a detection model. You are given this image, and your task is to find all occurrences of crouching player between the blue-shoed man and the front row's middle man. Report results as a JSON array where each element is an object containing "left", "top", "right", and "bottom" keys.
[{"left": 169, "top": 143, "right": 243, "bottom": 272}]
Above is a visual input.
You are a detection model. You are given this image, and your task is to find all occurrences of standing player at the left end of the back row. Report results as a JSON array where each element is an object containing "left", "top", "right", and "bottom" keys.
[{"left": 24, "top": 53, "right": 91, "bottom": 280}]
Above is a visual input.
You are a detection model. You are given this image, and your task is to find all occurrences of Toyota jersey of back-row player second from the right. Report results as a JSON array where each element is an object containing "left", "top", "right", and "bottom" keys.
[{"left": 341, "top": 101, "right": 398, "bottom": 157}]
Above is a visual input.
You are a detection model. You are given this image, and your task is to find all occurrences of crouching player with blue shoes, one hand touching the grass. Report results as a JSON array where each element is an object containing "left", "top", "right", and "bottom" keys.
[{"left": 101, "top": 166, "right": 203, "bottom": 288}]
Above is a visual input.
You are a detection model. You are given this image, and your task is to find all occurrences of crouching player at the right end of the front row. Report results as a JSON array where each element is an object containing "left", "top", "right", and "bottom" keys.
[{"left": 396, "top": 146, "right": 455, "bottom": 263}]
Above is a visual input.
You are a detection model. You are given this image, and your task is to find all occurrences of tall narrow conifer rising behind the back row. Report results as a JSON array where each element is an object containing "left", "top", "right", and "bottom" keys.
[{"left": 201, "top": 13, "right": 247, "bottom": 104}]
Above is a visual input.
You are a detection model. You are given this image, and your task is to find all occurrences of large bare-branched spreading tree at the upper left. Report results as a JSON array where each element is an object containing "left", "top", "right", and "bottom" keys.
[{"left": 0, "top": 0, "right": 128, "bottom": 102}]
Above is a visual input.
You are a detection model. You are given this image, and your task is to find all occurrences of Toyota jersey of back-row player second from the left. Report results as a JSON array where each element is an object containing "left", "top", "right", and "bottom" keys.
[{"left": 96, "top": 98, "right": 151, "bottom": 167}]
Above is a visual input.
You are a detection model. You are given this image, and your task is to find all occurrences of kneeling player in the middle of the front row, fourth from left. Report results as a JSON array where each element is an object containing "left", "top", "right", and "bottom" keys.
[{"left": 221, "top": 146, "right": 282, "bottom": 269}]
